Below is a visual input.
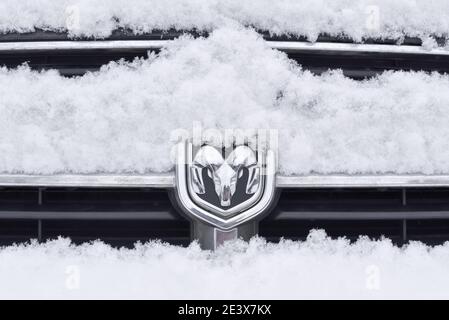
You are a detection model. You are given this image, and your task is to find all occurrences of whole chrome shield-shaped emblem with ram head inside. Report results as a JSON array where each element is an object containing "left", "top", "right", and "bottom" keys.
[{"left": 175, "top": 140, "right": 276, "bottom": 230}]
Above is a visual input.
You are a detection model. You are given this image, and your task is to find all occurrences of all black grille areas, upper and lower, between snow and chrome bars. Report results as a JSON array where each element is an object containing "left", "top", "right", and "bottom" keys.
[{"left": 0, "top": 30, "right": 449, "bottom": 246}]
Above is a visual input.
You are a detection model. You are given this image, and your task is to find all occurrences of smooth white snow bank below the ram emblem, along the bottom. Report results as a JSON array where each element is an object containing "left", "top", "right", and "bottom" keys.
[{"left": 0, "top": 231, "right": 449, "bottom": 299}]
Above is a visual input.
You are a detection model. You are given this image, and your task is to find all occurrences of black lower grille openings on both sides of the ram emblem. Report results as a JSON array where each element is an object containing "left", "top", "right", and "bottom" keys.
[{"left": 0, "top": 187, "right": 449, "bottom": 246}]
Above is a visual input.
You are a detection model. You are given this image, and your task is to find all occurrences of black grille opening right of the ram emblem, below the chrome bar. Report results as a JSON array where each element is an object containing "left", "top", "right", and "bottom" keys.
[{"left": 268, "top": 187, "right": 449, "bottom": 244}]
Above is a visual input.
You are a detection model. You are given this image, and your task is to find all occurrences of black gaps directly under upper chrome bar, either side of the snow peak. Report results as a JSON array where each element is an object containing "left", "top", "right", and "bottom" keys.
[{"left": 0, "top": 49, "right": 449, "bottom": 79}]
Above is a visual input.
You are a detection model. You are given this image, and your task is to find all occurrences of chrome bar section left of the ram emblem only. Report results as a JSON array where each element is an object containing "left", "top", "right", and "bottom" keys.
[{"left": 0, "top": 174, "right": 174, "bottom": 188}]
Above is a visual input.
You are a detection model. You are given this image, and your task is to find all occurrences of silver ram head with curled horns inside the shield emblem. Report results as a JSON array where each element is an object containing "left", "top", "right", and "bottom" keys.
[{"left": 191, "top": 145, "right": 260, "bottom": 207}]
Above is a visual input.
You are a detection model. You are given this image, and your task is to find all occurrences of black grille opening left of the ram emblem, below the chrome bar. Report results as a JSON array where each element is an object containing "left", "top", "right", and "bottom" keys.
[{"left": 0, "top": 187, "right": 190, "bottom": 246}]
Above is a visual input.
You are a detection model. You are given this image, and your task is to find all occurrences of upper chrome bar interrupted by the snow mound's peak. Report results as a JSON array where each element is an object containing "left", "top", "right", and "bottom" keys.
[{"left": 0, "top": 40, "right": 449, "bottom": 55}]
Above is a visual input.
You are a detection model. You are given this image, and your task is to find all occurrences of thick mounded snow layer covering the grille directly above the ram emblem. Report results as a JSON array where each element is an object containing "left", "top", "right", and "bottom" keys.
[{"left": 0, "top": 27, "right": 449, "bottom": 175}]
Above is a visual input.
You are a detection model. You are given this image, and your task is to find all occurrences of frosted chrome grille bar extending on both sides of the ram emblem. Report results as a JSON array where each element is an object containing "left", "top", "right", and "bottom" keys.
[{"left": 0, "top": 173, "right": 449, "bottom": 188}]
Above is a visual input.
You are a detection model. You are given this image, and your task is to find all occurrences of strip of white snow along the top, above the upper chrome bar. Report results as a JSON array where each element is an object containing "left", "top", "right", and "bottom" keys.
[{"left": 0, "top": 0, "right": 449, "bottom": 40}]
